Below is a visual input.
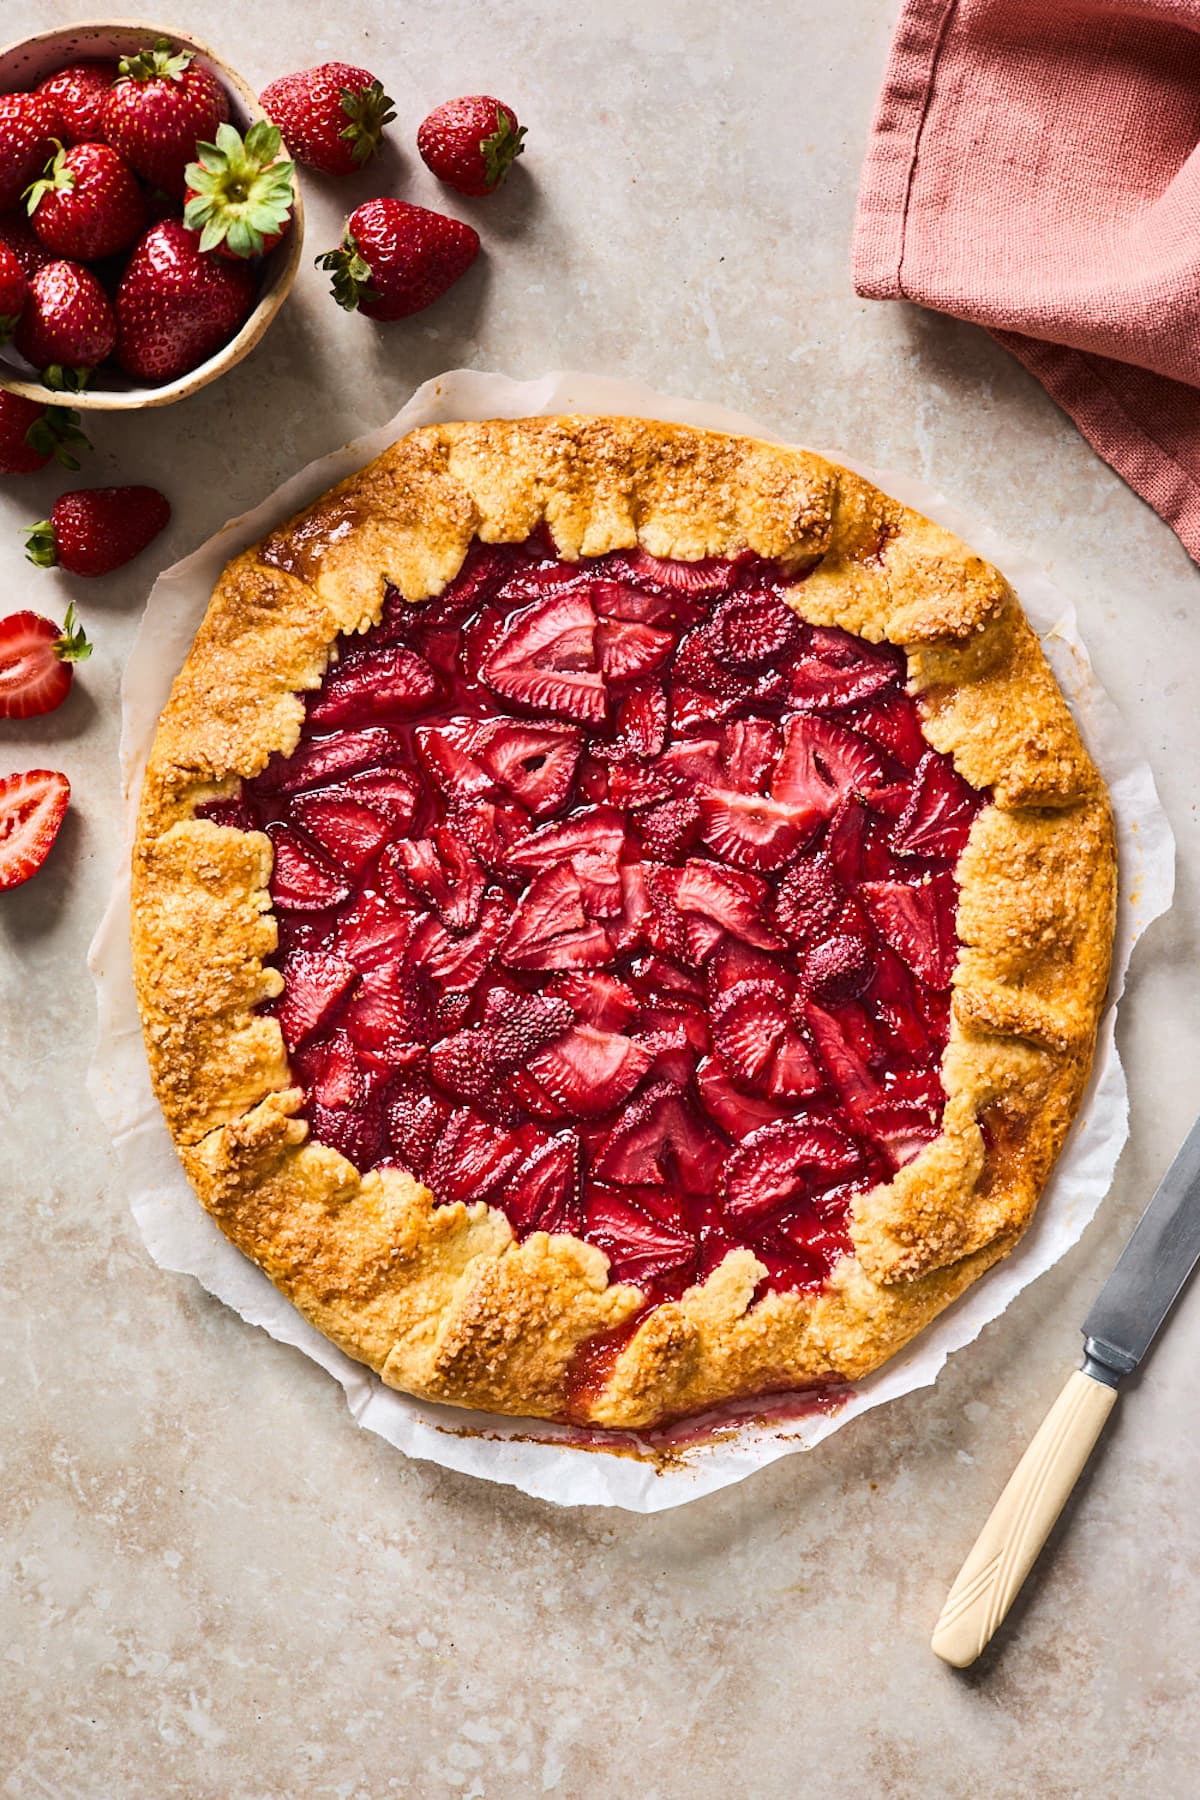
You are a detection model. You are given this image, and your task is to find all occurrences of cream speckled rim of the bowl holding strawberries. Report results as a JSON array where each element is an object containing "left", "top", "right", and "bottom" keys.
[{"left": 0, "top": 18, "right": 304, "bottom": 412}]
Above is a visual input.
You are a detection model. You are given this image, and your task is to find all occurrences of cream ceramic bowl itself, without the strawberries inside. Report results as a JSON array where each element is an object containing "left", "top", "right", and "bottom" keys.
[{"left": 0, "top": 20, "right": 304, "bottom": 412}]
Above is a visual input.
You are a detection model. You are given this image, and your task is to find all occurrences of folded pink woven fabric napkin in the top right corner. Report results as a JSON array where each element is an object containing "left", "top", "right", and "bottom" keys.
[{"left": 855, "top": 0, "right": 1200, "bottom": 562}]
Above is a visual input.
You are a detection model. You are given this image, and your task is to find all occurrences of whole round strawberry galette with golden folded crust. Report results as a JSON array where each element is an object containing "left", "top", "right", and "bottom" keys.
[{"left": 133, "top": 418, "right": 1115, "bottom": 1426}]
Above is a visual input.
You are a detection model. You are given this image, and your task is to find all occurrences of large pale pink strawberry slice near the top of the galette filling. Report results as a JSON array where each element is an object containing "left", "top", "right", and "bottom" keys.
[{"left": 479, "top": 589, "right": 608, "bottom": 725}]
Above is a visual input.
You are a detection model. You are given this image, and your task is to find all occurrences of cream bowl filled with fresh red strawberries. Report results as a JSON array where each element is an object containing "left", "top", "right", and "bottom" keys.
[{"left": 0, "top": 23, "right": 304, "bottom": 412}]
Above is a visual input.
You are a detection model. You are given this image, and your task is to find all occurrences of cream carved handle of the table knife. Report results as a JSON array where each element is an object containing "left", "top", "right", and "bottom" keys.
[{"left": 934, "top": 1368, "right": 1117, "bottom": 1669}]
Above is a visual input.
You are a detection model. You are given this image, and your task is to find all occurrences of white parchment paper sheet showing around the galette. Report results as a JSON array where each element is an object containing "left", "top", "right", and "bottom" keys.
[{"left": 88, "top": 369, "right": 1175, "bottom": 1512}]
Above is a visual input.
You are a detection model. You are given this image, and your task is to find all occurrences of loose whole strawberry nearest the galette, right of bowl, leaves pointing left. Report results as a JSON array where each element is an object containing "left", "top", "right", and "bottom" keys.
[{"left": 317, "top": 200, "right": 479, "bottom": 320}]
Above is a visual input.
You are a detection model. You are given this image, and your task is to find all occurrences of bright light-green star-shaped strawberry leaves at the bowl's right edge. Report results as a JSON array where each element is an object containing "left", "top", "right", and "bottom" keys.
[{"left": 184, "top": 119, "right": 295, "bottom": 257}]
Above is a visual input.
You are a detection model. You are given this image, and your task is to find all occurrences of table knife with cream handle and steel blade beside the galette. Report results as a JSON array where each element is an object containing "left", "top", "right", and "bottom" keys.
[{"left": 932, "top": 1120, "right": 1200, "bottom": 1669}]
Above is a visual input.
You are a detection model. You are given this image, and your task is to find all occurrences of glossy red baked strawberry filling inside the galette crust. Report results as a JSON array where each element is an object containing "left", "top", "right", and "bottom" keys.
[{"left": 201, "top": 536, "right": 984, "bottom": 1303}]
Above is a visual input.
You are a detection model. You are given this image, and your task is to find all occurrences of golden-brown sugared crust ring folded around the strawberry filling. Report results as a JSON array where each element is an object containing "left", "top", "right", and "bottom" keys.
[{"left": 133, "top": 418, "right": 1115, "bottom": 1427}]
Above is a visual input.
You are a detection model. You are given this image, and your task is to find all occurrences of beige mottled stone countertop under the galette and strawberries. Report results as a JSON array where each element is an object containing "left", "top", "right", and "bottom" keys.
[{"left": 0, "top": 0, "right": 1200, "bottom": 1800}]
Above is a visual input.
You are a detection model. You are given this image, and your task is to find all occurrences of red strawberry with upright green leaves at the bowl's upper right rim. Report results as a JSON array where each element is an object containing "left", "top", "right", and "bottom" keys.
[{"left": 103, "top": 38, "right": 228, "bottom": 194}]
